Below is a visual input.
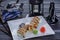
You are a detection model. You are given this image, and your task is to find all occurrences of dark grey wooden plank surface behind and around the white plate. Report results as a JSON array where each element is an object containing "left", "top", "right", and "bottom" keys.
[{"left": 0, "top": 0, "right": 60, "bottom": 40}]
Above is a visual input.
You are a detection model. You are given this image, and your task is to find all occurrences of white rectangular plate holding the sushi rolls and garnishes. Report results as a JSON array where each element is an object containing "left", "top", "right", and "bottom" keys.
[{"left": 7, "top": 16, "right": 55, "bottom": 40}]
